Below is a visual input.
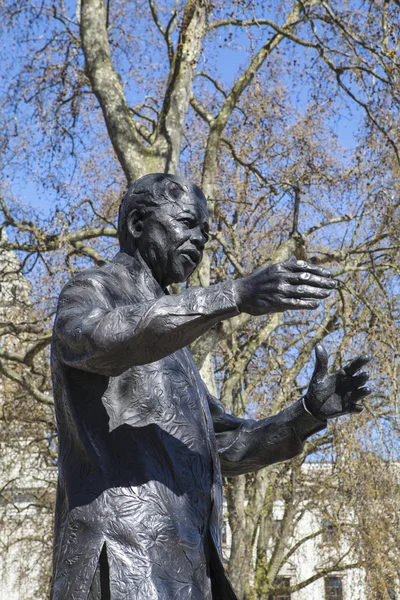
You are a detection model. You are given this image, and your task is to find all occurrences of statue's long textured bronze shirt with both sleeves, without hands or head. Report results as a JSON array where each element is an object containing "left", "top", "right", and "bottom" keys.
[{"left": 51, "top": 253, "right": 325, "bottom": 600}]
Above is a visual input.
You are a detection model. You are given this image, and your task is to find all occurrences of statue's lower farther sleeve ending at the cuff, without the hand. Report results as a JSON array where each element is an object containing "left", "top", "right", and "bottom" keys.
[{"left": 209, "top": 397, "right": 326, "bottom": 477}]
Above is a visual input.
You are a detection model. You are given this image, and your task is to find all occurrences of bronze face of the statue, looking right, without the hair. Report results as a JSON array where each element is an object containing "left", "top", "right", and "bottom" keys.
[{"left": 136, "top": 184, "right": 208, "bottom": 288}]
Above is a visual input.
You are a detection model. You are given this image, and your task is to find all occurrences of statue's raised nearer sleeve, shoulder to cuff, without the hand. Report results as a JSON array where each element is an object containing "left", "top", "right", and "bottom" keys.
[{"left": 53, "top": 274, "right": 239, "bottom": 376}]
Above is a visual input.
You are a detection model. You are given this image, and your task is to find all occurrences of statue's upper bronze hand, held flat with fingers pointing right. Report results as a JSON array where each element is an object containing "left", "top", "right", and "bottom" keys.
[{"left": 234, "top": 256, "right": 336, "bottom": 315}]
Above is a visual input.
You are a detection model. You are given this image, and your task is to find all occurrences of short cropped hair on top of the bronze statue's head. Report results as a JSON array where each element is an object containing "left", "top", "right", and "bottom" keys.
[{"left": 118, "top": 173, "right": 207, "bottom": 250}]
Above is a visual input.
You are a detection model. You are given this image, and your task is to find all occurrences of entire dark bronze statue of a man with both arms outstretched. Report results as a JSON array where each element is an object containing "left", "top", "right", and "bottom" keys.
[{"left": 52, "top": 174, "right": 370, "bottom": 600}]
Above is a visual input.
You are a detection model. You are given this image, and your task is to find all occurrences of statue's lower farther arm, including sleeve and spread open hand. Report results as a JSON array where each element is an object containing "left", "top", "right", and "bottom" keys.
[{"left": 209, "top": 344, "right": 371, "bottom": 477}]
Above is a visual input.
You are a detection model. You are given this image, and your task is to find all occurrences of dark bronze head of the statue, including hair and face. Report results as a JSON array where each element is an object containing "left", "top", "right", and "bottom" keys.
[{"left": 118, "top": 173, "right": 208, "bottom": 288}]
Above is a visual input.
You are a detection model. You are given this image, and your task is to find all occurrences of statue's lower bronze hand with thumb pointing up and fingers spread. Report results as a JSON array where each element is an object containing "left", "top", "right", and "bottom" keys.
[{"left": 304, "top": 344, "right": 371, "bottom": 420}]
